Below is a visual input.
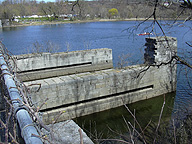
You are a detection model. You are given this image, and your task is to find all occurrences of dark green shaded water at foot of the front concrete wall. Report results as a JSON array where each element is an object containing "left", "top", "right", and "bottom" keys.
[{"left": 74, "top": 93, "right": 175, "bottom": 142}]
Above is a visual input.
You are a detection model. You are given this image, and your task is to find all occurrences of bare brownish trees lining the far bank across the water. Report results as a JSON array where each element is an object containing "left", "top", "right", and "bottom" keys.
[{"left": 0, "top": 0, "right": 190, "bottom": 21}]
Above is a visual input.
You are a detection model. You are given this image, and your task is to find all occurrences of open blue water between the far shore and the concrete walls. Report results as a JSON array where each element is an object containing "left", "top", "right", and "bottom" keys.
[{"left": 0, "top": 21, "right": 192, "bottom": 62}]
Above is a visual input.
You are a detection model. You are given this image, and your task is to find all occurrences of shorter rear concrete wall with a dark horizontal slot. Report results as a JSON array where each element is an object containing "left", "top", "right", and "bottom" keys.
[{"left": 13, "top": 48, "right": 113, "bottom": 81}]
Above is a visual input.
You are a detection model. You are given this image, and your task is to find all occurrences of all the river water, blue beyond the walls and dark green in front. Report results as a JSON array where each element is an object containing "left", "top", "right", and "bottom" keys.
[{"left": 0, "top": 21, "right": 192, "bottom": 142}]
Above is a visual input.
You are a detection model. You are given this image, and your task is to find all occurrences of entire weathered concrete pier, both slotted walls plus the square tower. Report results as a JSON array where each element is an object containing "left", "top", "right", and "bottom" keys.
[{"left": 11, "top": 37, "right": 177, "bottom": 124}]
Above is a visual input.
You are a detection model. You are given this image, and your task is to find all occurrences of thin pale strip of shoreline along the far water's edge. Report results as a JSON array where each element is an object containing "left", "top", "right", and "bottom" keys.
[{"left": 0, "top": 18, "right": 188, "bottom": 28}]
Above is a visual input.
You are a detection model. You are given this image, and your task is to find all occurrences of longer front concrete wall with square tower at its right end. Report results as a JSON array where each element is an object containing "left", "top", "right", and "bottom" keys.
[{"left": 14, "top": 37, "right": 177, "bottom": 124}]
